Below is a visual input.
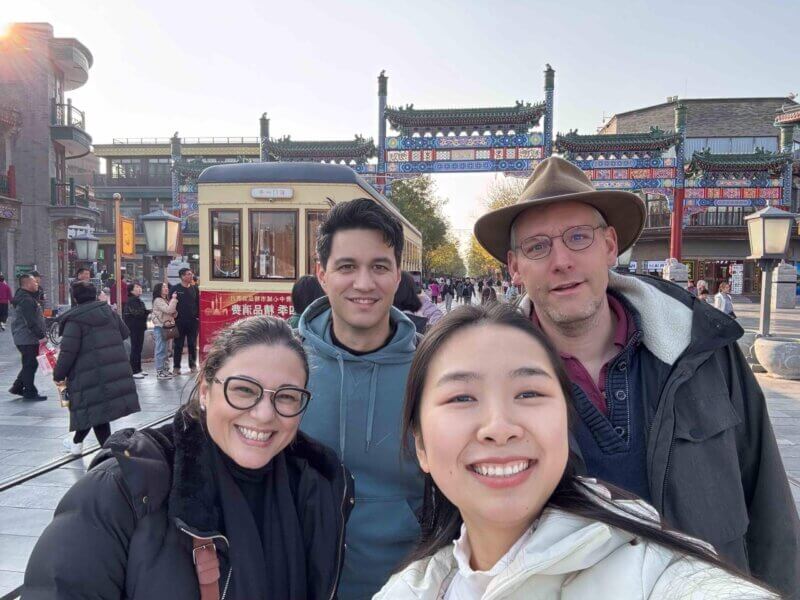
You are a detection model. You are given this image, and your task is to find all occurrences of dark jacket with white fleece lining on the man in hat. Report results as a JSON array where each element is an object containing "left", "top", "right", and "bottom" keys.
[{"left": 520, "top": 272, "right": 800, "bottom": 598}]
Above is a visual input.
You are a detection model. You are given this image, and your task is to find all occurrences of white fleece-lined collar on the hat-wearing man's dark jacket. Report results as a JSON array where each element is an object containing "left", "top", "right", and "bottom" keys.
[{"left": 519, "top": 271, "right": 743, "bottom": 365}]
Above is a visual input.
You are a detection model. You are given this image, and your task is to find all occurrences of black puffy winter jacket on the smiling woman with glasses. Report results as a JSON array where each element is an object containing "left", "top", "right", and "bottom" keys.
[{"left": 22, "top": 412, "right": 354, "bottom": 600}]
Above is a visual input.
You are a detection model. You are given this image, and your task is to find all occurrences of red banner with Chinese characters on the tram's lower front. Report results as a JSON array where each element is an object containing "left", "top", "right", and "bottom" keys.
[{"left": 200, "top": 289, "right": 294, "bottom": 358}]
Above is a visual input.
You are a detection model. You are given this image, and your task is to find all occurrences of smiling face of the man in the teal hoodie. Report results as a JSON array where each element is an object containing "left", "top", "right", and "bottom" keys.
[{"left": 317, "top": 229, "right": 400, "bottom": 342}]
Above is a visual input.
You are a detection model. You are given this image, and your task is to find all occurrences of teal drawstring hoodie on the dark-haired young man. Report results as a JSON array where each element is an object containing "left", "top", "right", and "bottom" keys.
[{"left": 299, "top": 297, "right": 423, "bottom": 600}]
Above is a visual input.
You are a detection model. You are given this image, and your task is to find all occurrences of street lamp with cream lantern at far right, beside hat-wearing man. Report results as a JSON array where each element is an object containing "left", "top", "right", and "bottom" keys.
[{"left": 744, "top": 206, "right": 796, "bottom": 337}]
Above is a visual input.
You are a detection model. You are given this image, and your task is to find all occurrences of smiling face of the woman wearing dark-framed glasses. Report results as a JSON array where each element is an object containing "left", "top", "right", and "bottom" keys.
[{"left": 200, "top": 345, "right": 306, "bottom": 469}]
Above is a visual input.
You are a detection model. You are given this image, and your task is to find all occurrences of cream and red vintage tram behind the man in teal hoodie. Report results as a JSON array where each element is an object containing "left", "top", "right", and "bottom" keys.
[{"left": 197, "top": 162, "right": 422, "bottom": 355}]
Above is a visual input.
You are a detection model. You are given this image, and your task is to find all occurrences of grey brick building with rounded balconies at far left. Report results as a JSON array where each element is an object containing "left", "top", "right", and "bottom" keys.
[{"left": 0, "top": 23, "right": 100, "bottom": 307}]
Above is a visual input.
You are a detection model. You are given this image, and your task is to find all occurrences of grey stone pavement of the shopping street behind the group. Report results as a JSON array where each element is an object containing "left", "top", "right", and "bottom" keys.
[{"left": 0, "top": 303, "right": 800, "bottom": 598}]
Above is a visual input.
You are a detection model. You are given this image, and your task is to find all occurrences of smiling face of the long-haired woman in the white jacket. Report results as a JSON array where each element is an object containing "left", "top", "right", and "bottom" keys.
[{"left": 414, "top": 325, "right": 568, "bottom": 533}]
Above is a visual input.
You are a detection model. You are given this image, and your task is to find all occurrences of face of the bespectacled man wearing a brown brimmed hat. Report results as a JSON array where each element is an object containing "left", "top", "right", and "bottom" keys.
[{"left": 508, "top": 202, "right": 617, "bottom": 326}]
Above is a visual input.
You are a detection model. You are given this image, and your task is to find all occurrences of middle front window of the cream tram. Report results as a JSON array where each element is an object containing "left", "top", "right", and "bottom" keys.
[{"left": 250, "top": 210, "right": 297, "bottom": 279}]
